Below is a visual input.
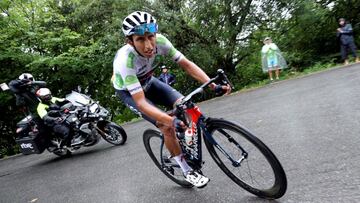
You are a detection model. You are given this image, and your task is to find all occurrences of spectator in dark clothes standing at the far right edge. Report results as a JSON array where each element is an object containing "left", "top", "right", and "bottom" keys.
[{"left": 336, "top": 18, "right": 360, "bottom": 65}]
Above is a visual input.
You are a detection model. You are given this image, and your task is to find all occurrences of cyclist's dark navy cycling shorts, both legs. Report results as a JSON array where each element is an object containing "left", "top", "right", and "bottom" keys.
[{"left": 115, "top": 77, "right": 183, "bottom": 126}]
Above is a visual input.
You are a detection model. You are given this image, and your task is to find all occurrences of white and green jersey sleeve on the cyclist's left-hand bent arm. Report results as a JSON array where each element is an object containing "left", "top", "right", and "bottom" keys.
[{"left": 112, "top": 50, "right": 142, "bottom": 94}]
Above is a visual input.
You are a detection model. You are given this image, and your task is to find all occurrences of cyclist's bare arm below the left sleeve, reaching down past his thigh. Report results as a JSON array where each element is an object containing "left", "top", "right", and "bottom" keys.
[{"left": 132, "top": 91, "right": 174, "bottom": 127}]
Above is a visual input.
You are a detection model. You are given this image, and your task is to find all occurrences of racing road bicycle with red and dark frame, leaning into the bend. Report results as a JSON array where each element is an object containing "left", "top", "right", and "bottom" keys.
[{"left": 143, "top": 69, "right": 287, "bottom": 199}]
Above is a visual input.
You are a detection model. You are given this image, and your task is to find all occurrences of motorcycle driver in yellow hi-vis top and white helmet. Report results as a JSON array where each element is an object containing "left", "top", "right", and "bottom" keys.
[{"left": 36, "top": 88, "right": 85, "bottom": 146}]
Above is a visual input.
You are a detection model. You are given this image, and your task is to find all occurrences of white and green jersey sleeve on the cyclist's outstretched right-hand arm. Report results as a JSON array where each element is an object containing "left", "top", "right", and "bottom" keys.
[{"left": 156, "top": 34, "right": 184, "bottom": 63}]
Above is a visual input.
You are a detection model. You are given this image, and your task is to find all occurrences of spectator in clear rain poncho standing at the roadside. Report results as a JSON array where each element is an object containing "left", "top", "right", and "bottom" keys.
[{"left": 261, "top": 37, "right": 287, "bottom": 81}]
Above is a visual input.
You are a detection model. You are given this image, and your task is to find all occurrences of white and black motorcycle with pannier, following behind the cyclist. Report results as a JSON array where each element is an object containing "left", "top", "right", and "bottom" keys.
[{"left": 1, "top": 82, "right": 127, "bottom": 157}]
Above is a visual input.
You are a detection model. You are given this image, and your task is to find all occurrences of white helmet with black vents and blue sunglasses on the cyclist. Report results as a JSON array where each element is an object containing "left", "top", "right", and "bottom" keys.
[{"left": 122, "top": 11, "right": 158, "bottom": 36}]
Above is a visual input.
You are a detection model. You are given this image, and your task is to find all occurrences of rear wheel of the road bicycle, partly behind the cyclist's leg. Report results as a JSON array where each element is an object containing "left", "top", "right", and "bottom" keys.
[{"left": 143, "top": 129, "right": 193, "bottom": 188}]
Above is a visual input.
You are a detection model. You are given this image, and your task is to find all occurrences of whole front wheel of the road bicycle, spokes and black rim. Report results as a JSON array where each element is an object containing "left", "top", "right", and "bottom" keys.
[{"left": 204, "top": 119, "right": 287, "bottom": 199}]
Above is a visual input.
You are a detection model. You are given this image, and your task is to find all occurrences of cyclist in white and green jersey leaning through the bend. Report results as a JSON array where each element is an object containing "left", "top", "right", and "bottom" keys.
[{"left": 112, "top": 11, "right": 231, "bottom": 188}]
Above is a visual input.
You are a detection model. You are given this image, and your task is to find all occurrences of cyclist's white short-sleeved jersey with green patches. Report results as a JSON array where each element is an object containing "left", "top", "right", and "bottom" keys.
[{"left": 112, "top": 34, "right": 184, "bottom": 94}]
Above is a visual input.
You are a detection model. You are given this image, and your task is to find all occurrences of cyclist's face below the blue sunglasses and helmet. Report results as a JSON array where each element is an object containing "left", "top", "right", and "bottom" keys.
[{"left": 131, "top": 32, "right": 156, "bottom": 58}]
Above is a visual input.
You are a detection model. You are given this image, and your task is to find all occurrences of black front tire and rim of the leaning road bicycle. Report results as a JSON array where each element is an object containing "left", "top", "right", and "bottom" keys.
[{"left": 204, "top": 119, "right": 287, "bottom": 199}]
